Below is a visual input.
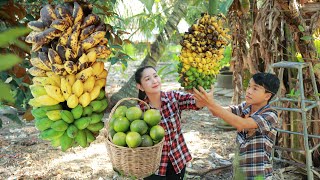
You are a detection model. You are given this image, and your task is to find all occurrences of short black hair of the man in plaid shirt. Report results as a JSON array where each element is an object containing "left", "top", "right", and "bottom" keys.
[{"left": 252, "top": 73, "right": 280, "bottom": 101}]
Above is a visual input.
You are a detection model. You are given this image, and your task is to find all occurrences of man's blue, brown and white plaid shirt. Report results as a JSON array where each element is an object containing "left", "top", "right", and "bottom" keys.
[{"left": 229, "top": 102, "right": 278, "bottom": 179}]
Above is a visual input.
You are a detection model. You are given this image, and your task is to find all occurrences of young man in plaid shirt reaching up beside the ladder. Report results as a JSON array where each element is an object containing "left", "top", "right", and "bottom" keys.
[{"left": 193, "top": 73, "right": 280, "bottom": 180}]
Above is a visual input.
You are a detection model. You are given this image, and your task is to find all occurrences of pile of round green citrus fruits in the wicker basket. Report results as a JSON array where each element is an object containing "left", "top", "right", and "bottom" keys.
[{"left": 108, "top": 106, "right": 165, "bottom": 148}]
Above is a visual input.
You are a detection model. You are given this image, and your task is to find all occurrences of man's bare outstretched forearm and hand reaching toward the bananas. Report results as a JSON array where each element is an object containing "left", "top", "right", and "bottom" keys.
[{"left": 193, "top": 86, "right": 258, "bottom": 131}]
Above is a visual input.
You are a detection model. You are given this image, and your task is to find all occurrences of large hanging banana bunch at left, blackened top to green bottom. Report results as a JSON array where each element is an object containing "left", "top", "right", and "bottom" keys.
[{"left": 26, "top": 2, "right": 111, "bottom": 151}]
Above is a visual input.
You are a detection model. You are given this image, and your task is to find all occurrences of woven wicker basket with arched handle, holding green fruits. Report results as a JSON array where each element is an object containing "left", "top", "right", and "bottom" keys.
[{"left": 104, "top": 98, "right": 164, "bottom": 179}]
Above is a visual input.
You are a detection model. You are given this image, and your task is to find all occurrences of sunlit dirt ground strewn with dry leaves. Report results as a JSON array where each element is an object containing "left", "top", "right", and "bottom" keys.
[{"left": 0, "top": 62, "right": 314, "bottom": 180}]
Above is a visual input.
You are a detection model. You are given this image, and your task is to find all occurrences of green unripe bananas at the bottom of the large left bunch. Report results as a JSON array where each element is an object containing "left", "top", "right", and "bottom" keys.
[{"left": 31, "top": 90, "right": 108, "bottom": 151}]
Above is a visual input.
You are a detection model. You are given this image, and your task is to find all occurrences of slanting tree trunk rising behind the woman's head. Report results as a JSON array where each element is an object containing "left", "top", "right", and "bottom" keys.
[{"left": 109, "top": 1, "right": 186, "bottom": 108}]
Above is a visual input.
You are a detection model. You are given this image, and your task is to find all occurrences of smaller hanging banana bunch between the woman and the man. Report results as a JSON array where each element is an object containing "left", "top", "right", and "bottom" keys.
[{"left": 178, "top": 13, "right": 231, "bottom": 90}]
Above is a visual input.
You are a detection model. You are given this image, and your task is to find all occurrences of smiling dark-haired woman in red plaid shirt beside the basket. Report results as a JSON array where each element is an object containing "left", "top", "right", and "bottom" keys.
[{"left": 135, "top": 66, "right": 203, "bottom": 180}]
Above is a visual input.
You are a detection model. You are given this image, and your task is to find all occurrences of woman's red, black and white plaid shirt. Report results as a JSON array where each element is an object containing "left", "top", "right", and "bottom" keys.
[{"left": 139, "top": 91, "right": 199, "bottom": 176}]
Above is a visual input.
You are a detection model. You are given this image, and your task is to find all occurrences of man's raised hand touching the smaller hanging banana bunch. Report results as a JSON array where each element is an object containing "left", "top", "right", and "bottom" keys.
[{"left": 193, "top": 85, "right": 215, "bottom": 106}]
